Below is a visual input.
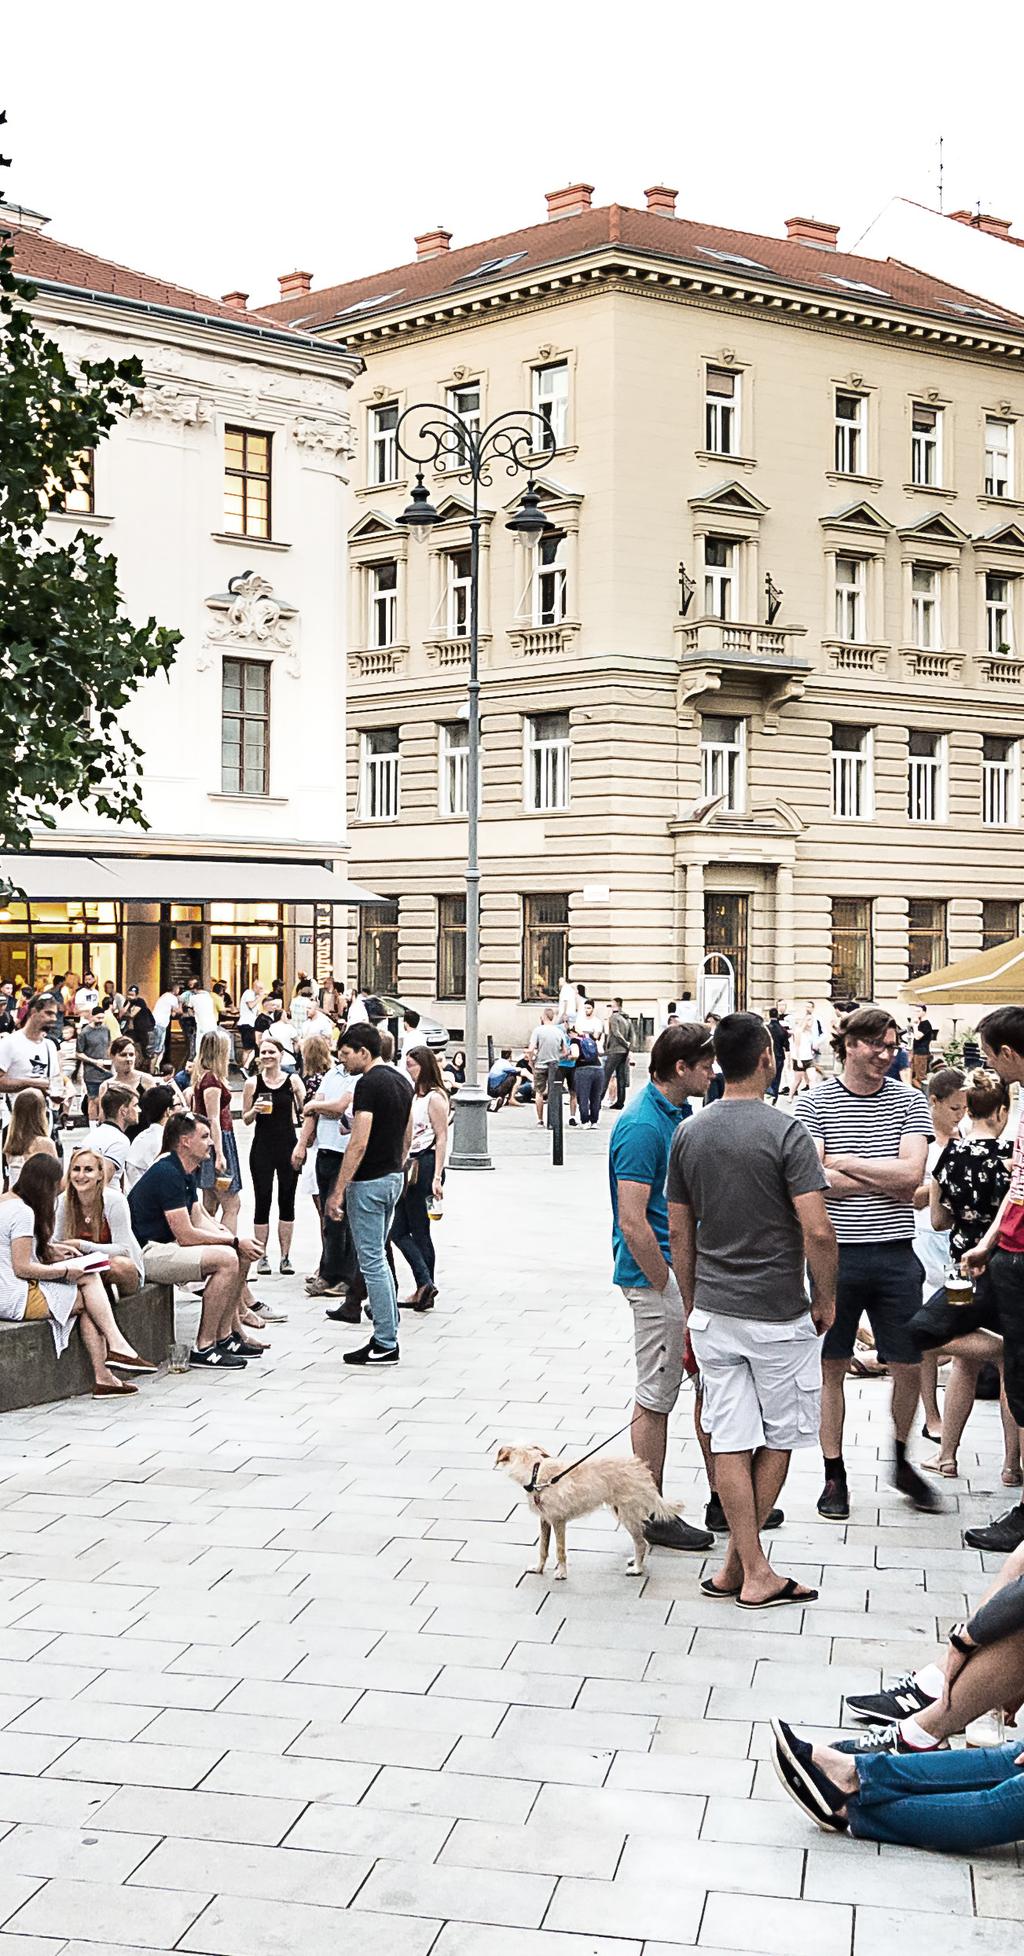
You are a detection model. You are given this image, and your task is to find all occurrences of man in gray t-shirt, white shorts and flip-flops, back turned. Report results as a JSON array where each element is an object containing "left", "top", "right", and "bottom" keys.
[{"left": 666, "top": 1011, "right": 836, "bottom": 1610}]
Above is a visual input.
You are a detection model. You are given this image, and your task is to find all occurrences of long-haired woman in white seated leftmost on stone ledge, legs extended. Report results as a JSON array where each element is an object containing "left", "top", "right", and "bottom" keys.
[{"left": 0, "top": 1154, "right": 156, "bottom": 1399}]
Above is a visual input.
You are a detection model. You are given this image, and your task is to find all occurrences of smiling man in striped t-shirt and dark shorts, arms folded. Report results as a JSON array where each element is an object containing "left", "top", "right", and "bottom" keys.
[{"left": 793, "top": 1005, "right": 940, "bottom": 1522}]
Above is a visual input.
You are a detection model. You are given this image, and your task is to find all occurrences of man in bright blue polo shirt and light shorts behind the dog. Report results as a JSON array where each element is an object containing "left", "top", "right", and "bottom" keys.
[{"left": 608, "top": 1025, "right": 715, "bottom": 1553}]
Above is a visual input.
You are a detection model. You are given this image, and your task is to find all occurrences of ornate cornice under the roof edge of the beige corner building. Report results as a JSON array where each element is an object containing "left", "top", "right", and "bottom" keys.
[{"left": 330, "top": 245, "right": 1024, "bottom": 360}]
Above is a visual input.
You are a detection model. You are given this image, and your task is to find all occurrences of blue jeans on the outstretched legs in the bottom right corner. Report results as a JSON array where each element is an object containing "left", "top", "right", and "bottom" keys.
[{"left": 846, "top": 1739, "right": 1024, "bottom": 1846}]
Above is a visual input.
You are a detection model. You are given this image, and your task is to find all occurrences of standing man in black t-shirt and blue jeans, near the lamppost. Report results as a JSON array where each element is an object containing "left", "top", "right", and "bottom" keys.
[{"left": 326, "top": 1025, "right": 412, "bottom": 1365}]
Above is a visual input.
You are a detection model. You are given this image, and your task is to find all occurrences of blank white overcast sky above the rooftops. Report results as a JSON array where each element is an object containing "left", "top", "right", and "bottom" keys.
[{"left": 8, "top": 0, "right": 1024, "bottom": 303}]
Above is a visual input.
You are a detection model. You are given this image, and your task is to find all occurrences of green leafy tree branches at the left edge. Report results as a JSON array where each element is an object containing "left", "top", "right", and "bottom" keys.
[{"left": 0, "top": 113, "right": 182, "bottom": 849}]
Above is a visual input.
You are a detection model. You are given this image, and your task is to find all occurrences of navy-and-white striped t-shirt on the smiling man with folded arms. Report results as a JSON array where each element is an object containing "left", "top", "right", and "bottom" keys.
[{"left": 793, "top": 1076, "right": 932, "bottom": 1242}]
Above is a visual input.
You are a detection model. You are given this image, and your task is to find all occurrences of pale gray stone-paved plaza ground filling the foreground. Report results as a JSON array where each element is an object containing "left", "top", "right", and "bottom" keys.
[{"left": 0, "top": 1111, "right": 1024, "bottom": 1956}]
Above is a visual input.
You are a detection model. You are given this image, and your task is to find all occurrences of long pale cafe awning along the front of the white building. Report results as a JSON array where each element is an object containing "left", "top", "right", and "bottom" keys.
[{"left": 0, "top": 851, "right": 381, "bottom": 904}]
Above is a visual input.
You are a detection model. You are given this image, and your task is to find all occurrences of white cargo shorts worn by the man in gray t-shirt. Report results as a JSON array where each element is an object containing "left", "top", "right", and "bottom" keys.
[{"left": 688, "top": 1311, "right": 821, "bottom": 1453}]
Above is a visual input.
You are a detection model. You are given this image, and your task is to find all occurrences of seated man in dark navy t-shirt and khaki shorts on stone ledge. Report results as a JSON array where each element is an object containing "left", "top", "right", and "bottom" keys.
[{"left": 129, "top": 1113, "right": 266, "bottom": 1371}]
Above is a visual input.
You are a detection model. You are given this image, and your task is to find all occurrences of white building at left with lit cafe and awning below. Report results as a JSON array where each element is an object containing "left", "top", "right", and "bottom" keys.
[{"left": 0, "top": 207, "right": 362, "bottom": 998}]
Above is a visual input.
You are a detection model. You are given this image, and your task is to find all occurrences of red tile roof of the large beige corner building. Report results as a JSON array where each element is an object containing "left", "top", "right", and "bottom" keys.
[{"left": 262, "top": 203, "right": 1024, "bottom": 331}]
